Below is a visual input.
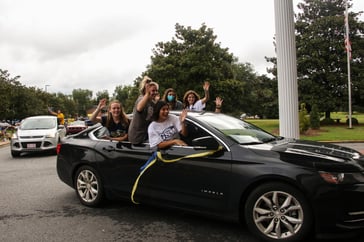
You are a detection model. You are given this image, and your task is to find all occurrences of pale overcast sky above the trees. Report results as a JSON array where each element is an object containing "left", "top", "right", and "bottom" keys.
[{"left": 0, "top": 0, "right": 364, "bottom": 95}]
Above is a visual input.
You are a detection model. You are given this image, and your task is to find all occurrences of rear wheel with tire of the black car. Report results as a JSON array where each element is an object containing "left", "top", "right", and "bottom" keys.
[{"left": 74, "top": 166, "right": 104, "bottom": 207}]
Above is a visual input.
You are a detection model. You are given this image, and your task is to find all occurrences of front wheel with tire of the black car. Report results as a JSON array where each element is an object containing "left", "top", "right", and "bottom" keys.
[{"left": 244, "top": 182, "right": 313, "bottom": 242}]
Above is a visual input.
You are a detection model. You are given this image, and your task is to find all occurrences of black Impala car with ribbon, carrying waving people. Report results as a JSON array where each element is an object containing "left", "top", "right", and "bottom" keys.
[{"left": 57, "top": 112, "right": 364, "bottom": 241}]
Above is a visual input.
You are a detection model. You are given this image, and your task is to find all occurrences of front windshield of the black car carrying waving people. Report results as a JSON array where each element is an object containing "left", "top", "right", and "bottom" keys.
[{"left": 198, "top": 114, "right": 277, "bottom": 144}]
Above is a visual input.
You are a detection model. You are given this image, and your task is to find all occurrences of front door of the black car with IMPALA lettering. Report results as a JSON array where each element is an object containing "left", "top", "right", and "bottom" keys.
[{"left": 136, "top": 121, "right": 232, "bottom": 210}]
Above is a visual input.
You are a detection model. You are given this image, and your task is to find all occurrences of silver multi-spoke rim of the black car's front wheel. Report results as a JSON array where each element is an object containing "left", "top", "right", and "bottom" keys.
[{"left": 253, "top": 191, "right": 304, "bottom": 239}]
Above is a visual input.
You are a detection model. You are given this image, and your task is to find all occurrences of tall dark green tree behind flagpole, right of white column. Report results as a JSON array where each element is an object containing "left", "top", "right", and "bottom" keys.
[{"left": 296, "top": 0, "right": 364, "bottom": 118}]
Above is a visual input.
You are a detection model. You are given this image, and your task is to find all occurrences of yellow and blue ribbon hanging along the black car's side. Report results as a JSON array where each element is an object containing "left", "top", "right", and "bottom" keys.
[{"left": 131, "top": 146, "right": 222, "bottom": 204}]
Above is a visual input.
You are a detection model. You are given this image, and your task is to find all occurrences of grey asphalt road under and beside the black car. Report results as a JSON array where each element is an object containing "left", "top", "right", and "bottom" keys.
[{"left": 0, "top": 146, "right": 364, "bottom": 242}]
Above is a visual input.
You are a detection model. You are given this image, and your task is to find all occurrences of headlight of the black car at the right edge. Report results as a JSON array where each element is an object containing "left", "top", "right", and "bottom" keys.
[{"left": 319, "top": 171, "right": 364, "bottom": 184}]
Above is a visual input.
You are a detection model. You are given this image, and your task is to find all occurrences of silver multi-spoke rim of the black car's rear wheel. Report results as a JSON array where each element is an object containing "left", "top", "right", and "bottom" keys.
[{"left": 77, "top": 170, "right": 99, "bottom": 203}]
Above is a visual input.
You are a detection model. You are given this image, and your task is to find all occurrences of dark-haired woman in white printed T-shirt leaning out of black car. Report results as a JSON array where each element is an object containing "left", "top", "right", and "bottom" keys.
[{"left": 148, "top": 100, "right": 187, "bottom": 149}]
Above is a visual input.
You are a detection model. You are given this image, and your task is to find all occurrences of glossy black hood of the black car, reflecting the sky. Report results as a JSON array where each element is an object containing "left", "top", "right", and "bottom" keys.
[{"left": 249, "top": 139, "right": 364, "bottom": 172}]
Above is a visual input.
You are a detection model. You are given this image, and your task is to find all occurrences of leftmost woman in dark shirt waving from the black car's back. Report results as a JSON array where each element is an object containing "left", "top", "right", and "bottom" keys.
[{"left": 90, "top": 98, "right": 130, "bottom": 141}]
